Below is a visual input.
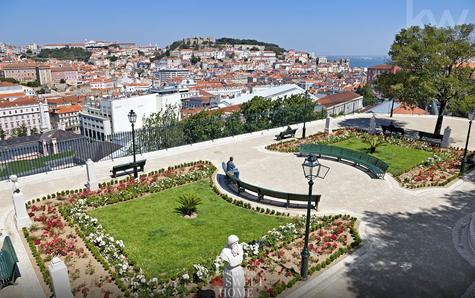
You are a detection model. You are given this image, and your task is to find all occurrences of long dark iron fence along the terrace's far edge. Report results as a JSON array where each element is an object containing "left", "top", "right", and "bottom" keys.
[{"left": 0, "top": 107, "right": 326, "bottom": 180}]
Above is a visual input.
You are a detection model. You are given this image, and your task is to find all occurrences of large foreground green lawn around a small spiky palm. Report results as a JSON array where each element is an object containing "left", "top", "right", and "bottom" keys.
[{"left": 90, "top": 180, "right": 291, "bottom": 278}]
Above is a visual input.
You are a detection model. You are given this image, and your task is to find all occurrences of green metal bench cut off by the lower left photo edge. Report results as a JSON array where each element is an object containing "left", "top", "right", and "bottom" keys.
[{"left": 0, "top": 236, "right": 20, "bottom": 289}]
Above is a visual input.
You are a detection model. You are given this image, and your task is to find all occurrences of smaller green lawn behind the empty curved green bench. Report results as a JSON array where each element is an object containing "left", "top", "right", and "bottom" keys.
[{"left": 331, "top": 137, "right": 433, "bottom": 176}]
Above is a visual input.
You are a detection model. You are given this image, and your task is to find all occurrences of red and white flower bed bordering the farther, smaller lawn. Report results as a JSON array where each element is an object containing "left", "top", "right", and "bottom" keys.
[{"left": 266, "top": 128, "right": 463, "bottom": 188}]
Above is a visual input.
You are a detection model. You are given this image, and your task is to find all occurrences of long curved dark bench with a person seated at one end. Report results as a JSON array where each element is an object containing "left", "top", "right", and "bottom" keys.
[{"left": 222, "top": 163, "right": 321, "bottom": 210}]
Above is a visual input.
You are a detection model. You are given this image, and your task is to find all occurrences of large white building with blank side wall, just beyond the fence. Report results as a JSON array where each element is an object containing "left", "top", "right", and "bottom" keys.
[{"left": 79, "top": 92, "right": 181, "bottom": 139}]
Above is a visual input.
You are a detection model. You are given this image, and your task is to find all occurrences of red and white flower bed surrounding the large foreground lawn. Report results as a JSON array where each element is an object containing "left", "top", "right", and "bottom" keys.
[{"left": 24, "top": 162, "right": 361, "bottom": 297}]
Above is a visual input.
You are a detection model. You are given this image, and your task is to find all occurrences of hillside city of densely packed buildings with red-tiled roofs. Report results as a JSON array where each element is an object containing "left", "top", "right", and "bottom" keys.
[{"left": 0, "top": 37, "right": 367, "bottom": 139}]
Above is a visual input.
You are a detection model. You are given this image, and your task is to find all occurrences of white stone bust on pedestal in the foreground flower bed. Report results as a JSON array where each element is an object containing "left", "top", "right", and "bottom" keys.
[{"left": 219, "top": 235, "right": 245, "bottom": 298}]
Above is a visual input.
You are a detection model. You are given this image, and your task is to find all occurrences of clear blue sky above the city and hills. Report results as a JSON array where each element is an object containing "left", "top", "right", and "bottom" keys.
[{"left": 0, "top": 0, "right": 475, "bottom": 56}]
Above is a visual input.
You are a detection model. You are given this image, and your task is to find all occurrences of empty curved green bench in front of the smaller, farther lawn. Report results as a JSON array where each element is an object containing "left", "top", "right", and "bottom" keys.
[{"left": 300, "top": 144, "right": 389, "bottom": 178}]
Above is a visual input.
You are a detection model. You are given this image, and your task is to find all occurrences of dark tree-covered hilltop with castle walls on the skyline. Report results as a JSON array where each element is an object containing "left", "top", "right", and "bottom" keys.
[{"left": 167, "top": 37, "right": 285, "bottom": 55}]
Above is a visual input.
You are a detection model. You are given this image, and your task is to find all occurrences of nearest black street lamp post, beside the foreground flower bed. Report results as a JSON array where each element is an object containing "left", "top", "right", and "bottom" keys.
[{"left": 300, "top": 155, "right": 330, "bottom": 280}]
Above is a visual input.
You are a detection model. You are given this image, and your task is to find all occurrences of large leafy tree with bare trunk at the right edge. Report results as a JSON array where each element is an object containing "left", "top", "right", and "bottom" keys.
[{"left": 375, "top": 24, "right": 475, "bottom": 134}]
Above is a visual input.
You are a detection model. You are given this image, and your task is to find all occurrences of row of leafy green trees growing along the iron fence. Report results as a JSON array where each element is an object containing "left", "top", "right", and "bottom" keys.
[{"left": 137, "top": 95, "right": 326, "bottom": 152}]
